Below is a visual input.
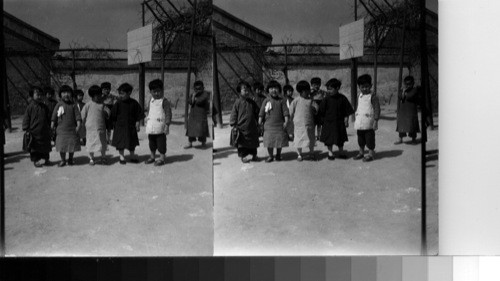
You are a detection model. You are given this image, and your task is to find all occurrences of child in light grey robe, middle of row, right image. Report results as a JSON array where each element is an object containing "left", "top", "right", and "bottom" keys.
[{"left": 290, "top": 80, "right": 318, "bottom": 161}]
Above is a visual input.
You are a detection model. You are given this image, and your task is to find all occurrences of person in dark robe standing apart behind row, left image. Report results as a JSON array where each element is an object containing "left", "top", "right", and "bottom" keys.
[{"left": 184, "top": 81, "right": 210, "bottom": 148}]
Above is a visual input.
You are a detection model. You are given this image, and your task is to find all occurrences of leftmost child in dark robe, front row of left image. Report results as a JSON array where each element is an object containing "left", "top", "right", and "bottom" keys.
[{"left": 23, "top": 87, "right": 52, "bottom": 168}]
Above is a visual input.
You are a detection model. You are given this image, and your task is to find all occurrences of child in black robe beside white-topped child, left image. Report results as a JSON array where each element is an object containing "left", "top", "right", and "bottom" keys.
[{"left": 111, "top": 83, "right": 144, "bottom": 165}]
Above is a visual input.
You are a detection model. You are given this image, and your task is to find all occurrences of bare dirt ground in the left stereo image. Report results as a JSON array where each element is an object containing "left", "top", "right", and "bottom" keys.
[{"left": 5, "top": 110, "right": 213, "bottom": 256}]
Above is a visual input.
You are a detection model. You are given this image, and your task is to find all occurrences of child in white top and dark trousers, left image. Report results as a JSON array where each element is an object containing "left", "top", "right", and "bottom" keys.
[{"left": 146, "top": 79, "right": 172, "bottom": 166}]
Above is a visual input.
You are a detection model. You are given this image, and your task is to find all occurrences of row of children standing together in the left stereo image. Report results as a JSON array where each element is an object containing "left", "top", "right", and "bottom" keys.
[{"left": 23, "top": 79, "right": 176, "bottom": 167}]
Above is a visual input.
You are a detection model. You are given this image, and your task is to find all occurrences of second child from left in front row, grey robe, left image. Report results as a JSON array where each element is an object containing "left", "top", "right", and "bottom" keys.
[{"left": 51, "top": 85, "right": 82, "bottom": 167}]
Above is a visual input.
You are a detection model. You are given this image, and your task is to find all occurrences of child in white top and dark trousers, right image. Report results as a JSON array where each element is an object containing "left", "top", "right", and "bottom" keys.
[{"left": 354, "top": 74, "right": 380, "bottom": 162}]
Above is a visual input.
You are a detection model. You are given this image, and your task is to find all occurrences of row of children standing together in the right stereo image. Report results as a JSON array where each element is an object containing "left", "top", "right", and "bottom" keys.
[{"left": 230, "top": 74, "right": 380, "bottom": 163}]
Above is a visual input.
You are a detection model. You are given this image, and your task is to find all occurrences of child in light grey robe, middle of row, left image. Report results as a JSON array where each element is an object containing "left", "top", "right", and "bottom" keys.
[{"left": 82, "top": 85, "right": 111, "bottom": 166}]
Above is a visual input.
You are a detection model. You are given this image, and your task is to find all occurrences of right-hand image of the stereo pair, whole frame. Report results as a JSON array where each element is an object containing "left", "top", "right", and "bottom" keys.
[{"left": 212, "top": 0, "right": 439, "bottom": 256}]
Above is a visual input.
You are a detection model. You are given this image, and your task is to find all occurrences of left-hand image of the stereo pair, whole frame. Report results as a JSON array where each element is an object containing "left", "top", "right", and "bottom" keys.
[{"left": 0, "top": 0, "right": 214, "bottom": 256}]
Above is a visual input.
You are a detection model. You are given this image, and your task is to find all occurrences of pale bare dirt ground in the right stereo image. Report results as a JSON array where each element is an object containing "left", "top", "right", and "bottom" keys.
[{"left": 214, "top": 102, "right": 438, "bottom": 255}]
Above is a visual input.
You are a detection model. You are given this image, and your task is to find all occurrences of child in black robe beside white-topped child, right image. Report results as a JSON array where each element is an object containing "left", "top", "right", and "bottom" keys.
[{"left": 319, "top": 78, "right": 354, "bottom": 160}]
